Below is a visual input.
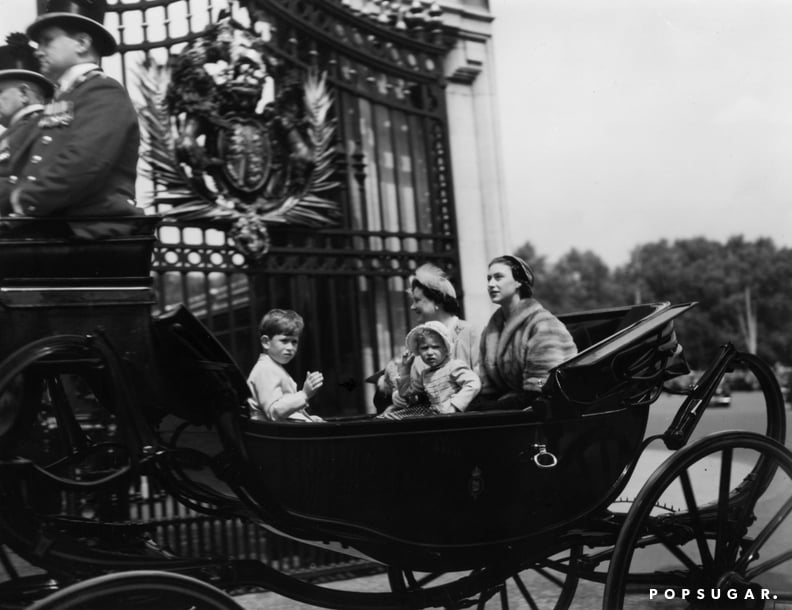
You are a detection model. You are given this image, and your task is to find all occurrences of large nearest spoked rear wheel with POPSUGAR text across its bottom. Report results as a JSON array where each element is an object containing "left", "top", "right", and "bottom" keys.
[{"left": 603, "top": 432, "right": 792, "bottom": 610}]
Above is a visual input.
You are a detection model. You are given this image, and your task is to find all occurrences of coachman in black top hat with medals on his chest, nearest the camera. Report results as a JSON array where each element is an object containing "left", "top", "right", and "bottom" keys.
[{"left": 9, "top": 0, "right": 143, "bottom": 238}]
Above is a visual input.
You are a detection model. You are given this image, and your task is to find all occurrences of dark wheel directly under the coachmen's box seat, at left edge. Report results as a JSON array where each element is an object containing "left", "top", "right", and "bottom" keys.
[{"left": 0, "top": 335, "right": 135, "bottom": 496}]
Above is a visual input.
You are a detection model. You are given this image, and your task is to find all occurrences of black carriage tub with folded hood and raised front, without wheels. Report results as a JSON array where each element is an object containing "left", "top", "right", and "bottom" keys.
[{"left": 154, "top": 303, "right": 687, "bottom": 570}]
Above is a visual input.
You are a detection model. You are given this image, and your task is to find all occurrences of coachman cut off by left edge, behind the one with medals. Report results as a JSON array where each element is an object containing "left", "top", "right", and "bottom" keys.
[{"left": 0, "top": 33, "right": 55, "bottom": 216}]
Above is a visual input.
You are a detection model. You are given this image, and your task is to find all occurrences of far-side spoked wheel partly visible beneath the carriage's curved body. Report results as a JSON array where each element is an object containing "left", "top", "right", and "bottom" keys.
[{"left": 388, "top": 545, "right": 582, "bottom": 610}]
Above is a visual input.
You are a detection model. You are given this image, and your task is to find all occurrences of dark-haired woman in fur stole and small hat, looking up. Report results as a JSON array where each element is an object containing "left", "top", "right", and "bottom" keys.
[{"left": 479, "top": 254, "right": 577, "bottom": 408}]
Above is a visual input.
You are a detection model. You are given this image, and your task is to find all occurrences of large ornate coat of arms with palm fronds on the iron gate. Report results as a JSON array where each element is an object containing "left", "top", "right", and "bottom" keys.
[{"left": 139, "top": 14, "right": 338, "bottom": 259}]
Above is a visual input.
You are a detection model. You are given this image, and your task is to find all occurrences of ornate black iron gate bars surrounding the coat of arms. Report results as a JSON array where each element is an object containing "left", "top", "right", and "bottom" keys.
[{"left": 106, "top": 0, "right": 458, "bottom": 415}]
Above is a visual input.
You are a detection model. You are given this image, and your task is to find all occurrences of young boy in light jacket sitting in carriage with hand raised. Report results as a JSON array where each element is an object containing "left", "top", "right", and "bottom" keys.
[{"left": 248, "top": 309, "right": 324, "bottom": 421}]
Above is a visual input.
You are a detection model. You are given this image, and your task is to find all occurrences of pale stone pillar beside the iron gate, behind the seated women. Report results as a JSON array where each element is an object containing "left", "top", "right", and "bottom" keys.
[{"left": 443, "top": 0, "right": 512, "bottom": 327}]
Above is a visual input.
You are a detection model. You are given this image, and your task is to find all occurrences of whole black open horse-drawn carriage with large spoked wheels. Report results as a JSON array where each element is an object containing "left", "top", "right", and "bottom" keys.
[{"left": 0, "top": 218, "right": 792, "bottom": 610}]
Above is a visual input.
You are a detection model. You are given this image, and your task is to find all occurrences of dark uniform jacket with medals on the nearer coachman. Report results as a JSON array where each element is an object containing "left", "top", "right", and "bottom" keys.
[{"left": 8, "top": 69, "right": 142, "bottom": 237}]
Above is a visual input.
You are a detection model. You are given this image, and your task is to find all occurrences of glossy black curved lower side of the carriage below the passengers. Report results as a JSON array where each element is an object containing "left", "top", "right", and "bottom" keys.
[{"left": 238, "top": 407, "right": 648, "bottom": 570}]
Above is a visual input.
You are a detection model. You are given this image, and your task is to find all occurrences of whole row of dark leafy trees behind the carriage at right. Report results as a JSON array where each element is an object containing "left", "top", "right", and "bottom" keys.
[{"left": 516, "top": 236, "right": 792, "bottom": 367}]
